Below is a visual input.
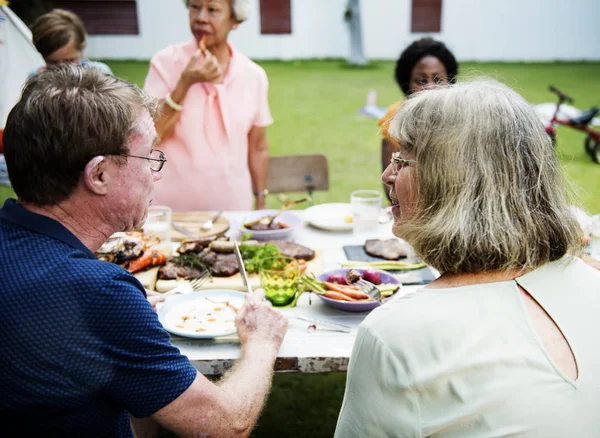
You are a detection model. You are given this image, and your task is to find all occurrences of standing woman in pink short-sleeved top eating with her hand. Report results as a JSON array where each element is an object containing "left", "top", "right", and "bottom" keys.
[{"left": 144, "top": 0, "right": 273, "bottom": 211}]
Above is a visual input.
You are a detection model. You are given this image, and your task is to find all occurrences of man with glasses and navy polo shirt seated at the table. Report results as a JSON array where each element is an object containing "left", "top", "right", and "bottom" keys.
[{"left": 0, "top": 65, "right": 287, "bottom": 437}]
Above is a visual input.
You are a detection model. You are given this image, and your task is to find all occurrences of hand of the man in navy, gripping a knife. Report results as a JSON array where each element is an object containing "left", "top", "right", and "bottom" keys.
[{"left": 235, "top": 289, "right": 288, "bottom": 351}]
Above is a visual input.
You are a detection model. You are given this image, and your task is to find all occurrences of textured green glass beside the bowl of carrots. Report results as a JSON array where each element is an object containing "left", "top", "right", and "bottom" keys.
[{"left": 258, "top": 256, "right": 300, "bottom": 306}]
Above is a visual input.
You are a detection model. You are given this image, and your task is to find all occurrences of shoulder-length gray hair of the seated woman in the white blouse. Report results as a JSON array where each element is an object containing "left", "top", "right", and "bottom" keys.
[{"left": 389, "top": 80, "right": 583, "bottom": 273}]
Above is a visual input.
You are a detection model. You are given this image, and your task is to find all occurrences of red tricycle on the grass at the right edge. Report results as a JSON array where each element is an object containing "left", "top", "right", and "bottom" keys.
[{"left": 546, "top": 85, "right": 600, "bottom": 163}]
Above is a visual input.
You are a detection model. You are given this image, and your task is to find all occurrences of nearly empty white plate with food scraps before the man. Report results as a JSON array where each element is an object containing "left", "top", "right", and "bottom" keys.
[{"left": 158, "top": 289, "right": 246, "bottom": 339}]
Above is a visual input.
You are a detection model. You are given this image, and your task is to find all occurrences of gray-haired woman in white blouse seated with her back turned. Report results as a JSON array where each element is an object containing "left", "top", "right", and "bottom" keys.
[{"left": 336, "top": 81, "right": 600, "bottom": 438}]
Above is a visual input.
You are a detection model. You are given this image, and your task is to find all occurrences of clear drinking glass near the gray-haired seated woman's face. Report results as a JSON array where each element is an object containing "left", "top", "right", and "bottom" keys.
[{"left": 350, "top": 190, "right": 382, "bottom": 241}]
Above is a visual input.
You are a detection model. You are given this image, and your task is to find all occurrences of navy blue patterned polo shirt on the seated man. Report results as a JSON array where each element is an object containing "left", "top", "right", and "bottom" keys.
[{"left": 0, "top": 199, "right": 196, "bottom": 437}]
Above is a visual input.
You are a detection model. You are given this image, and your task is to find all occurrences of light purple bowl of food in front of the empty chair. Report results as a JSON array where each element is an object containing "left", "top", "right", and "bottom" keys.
[{"left": 241, "top": 210, "right": 302, "bottom": 240}]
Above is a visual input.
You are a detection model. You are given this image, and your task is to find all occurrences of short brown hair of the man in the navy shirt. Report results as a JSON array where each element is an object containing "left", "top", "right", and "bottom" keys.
[{"left": 3, "top": 63, "right": 156, "bottom": 206}]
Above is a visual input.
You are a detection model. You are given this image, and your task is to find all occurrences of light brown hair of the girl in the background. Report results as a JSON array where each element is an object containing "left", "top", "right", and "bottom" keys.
[{"left": 31, "top": 9, "right": 85, "bottom": 59}]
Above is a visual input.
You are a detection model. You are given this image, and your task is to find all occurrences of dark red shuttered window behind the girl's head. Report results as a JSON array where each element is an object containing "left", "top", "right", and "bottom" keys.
[{"left": 52, "top": 0, "right": 139, "bottom": 35}]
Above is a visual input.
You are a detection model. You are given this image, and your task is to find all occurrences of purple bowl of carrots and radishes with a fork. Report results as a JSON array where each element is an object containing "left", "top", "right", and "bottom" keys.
[{"left": 317, "top": 268, "right": 401, "bottom": 312}]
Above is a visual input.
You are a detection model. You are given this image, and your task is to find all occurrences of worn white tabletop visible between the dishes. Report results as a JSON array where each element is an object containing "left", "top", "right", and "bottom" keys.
[{"left": 166, "top": 210, "right": 422, "bottom": 376}]
